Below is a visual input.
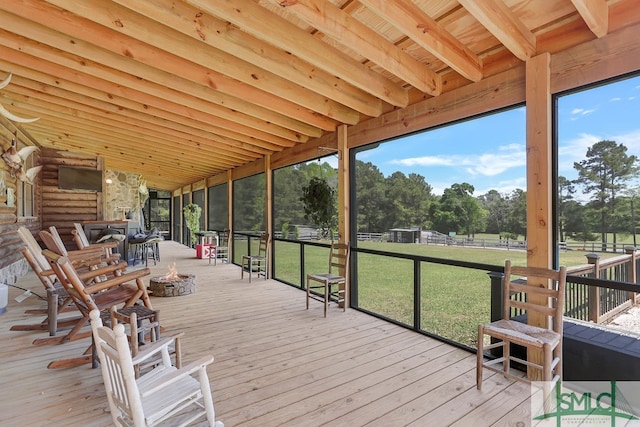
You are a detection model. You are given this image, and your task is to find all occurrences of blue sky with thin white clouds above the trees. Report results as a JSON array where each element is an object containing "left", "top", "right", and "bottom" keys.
[{"left": 357, "top": 77, "right": 640, "bottom": 198}]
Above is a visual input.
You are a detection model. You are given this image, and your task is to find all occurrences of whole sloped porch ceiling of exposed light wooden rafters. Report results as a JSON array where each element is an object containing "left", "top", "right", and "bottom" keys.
[{"left": 0, "top": 0, "right": 640, "bottom": 190}]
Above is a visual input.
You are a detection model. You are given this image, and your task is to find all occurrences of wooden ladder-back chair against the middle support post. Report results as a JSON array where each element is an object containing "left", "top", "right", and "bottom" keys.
[{"left": 307, "top": 243, "right": 349, "bottom": 317}]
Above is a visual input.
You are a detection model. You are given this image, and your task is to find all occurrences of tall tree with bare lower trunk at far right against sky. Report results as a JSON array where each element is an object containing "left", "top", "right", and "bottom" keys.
[{"left": 573, "top": 140, "right": 638, "bottom": 251}]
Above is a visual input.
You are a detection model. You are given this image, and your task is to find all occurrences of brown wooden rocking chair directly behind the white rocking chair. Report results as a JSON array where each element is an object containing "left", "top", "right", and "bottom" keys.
[{"left": 34, "top": 244, "right": 152, "bottom": 368}]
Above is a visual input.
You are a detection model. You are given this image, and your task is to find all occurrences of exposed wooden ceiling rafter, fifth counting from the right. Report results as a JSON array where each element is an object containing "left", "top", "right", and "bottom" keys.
[{"left": 186, "top": 0, "right": 409, "bottom": 107}]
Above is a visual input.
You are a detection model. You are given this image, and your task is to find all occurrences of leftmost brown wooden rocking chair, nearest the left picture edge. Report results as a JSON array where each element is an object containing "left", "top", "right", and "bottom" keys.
[{"left": 11, "top": 226, "right": 77, "bottom": 336}]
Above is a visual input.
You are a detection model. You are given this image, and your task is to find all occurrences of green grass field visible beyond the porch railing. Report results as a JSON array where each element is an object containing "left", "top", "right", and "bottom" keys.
[{"left": 243, "top": 241, "right": 615, "bottom": 347}]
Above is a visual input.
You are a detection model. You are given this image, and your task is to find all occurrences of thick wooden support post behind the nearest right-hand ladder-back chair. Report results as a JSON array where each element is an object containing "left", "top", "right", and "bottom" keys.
[{"left": 526, "top": 53, "right": 555, "bottom": 381}]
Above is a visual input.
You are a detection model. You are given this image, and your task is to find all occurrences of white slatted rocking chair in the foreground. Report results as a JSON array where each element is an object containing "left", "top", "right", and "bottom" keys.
[{"left": 90, "top": 310, "right": 224, "bottom": 427}]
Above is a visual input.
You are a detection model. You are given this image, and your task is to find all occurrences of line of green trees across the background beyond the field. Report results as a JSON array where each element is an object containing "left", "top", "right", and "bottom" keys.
[{"left": 226, "top": 140, "right": 640, "bottom": 245}]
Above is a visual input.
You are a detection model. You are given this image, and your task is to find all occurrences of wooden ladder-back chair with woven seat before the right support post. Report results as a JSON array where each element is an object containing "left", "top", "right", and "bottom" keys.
[{"left": 476, "top": 260, "right": 567, "bottom": 390}]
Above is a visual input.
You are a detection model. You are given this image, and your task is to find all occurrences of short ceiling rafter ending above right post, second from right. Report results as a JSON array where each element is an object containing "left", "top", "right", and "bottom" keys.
[{"left": 458, "top": 0, "right": 536, "bottom": 61}]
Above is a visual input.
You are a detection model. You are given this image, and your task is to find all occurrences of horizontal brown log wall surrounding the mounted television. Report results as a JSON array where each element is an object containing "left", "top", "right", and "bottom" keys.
[{"left": 40, "top": 148, "right": 103, "bottom": 248}]
